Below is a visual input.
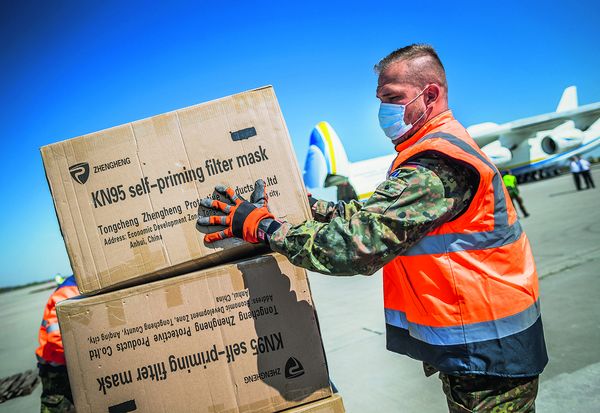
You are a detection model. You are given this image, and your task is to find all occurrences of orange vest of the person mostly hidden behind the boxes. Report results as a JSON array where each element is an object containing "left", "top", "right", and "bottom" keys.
[{"left": 35, "top": 276, "right": 79, "bottom": 366}]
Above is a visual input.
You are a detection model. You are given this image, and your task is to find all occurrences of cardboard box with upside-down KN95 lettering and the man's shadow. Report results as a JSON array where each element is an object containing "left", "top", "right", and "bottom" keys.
[{"left": 57, "top": 254, "right": 331, "bottom": 413}]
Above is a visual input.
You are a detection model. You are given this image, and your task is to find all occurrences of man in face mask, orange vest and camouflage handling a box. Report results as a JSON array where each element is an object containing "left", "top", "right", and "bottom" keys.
[{"left": 198, "top": 45, "right": 548, "bottom": 412}]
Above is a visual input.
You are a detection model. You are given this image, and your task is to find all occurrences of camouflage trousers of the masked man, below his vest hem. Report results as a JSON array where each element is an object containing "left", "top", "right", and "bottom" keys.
[{"left": 440, "top": 373, "right": 538, "bottom": 413}]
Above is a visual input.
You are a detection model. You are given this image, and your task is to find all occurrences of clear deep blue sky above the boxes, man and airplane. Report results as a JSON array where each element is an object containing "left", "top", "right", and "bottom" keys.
[{"left": 0, "top": 1, "right": 600, "bottom": 286}]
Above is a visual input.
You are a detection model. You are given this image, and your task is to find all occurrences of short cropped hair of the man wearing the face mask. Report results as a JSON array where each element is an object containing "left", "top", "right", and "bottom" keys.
[{"left": 374, "top": 43, "right": 448, "bottom": 89}]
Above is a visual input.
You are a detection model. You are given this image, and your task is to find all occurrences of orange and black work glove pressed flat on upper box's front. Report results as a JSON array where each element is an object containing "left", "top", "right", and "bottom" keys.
[{"left": 197, "top": 179, "right": 280, "bottom": 244}]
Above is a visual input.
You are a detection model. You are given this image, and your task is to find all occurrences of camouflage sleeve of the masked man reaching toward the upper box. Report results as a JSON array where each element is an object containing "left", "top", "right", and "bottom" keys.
[{"left": 269, "top": 166, "right": 454, "bottom": 275}]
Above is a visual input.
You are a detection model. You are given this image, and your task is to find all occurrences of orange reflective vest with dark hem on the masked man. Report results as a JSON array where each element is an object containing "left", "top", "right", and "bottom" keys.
[{"left": 383, "top": 111, "right": 548, "bottom": 377}]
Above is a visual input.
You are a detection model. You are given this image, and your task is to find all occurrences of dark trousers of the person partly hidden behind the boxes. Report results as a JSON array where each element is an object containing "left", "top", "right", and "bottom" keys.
[{"left": 40, "top": 367, "right": 75, "bottom": 413}]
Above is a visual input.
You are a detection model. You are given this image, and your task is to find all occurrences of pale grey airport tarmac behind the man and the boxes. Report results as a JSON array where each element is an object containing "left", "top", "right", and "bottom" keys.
[{"left": 0, "top": 169, "right": 600, "bottom": 413}]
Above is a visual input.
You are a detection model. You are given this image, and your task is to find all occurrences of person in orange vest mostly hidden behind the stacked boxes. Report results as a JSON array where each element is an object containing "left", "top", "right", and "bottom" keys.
[{"left": 35, "top": 275, "right": 79, "bottom": 413}]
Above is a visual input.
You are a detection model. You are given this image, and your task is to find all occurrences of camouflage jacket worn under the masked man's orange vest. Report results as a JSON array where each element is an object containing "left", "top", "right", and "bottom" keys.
[{"left": 269, "top": 155, "right": 478, "bottom": 275}]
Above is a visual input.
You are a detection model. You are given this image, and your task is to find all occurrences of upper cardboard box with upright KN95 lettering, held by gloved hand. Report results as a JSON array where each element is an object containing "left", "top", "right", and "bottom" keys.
[{"left": 41, "top": 87, "right": 310, "bottom": 294}]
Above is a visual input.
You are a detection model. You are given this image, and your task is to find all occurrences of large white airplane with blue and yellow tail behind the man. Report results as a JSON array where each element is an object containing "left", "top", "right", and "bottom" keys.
[{"left": 303, "top": 86, "right": 600, "bottom": 200}]
